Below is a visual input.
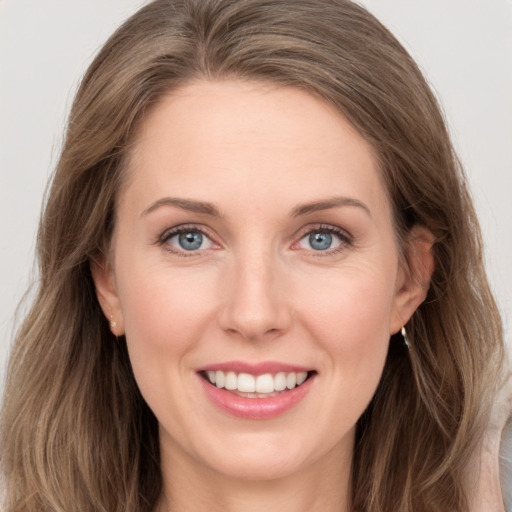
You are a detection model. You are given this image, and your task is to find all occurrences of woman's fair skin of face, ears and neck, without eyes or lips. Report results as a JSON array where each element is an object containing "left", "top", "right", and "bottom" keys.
[{"left": 93, "top": 80, "right": 432, "bottom": 512}]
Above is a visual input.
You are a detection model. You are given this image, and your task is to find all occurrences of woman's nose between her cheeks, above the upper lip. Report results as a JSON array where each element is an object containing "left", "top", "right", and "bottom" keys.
[{"left": 219, "top": 254, "right": 293, "bottom": 341}]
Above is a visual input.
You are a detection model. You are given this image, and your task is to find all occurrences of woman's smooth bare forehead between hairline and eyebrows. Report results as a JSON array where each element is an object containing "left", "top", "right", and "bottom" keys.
[{"left": 122, "top": 80, "right": 387, "bottom": 222}]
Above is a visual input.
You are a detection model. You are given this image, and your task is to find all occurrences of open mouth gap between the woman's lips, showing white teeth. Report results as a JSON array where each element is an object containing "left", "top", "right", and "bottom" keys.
[{"left": 200, "top": 370, "right": 316, "bottom": 398}]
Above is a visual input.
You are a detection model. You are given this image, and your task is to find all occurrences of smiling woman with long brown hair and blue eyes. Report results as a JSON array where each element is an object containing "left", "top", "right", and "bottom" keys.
[{"left": 2, "top": 0, "right": 503, "bottom": 512}]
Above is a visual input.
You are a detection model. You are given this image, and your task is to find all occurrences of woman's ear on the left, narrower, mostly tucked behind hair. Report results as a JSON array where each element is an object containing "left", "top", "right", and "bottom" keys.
[{"left": 90, "top": 256, "right": 124, "bottom": 336}]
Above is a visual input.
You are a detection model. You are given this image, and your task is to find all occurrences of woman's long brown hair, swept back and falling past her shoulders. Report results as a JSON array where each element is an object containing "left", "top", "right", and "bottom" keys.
[{"left": 1, "top": 0, "right": 503, "bottom": 512}]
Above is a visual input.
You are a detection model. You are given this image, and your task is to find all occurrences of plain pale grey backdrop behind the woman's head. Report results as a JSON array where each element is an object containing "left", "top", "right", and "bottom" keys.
[{"left": 0, "top": 0, "right": 512, "bottom": 504}]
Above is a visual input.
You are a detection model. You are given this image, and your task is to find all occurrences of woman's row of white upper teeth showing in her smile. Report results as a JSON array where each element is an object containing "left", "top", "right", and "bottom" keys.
[{"left": 206, "top": 370, "right": 308, "bottom": 394}]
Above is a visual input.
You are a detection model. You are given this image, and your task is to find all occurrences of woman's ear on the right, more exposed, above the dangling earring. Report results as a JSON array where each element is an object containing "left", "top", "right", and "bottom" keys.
[{"left": 390, "top": 226, "right": 434, "bottom": 334}]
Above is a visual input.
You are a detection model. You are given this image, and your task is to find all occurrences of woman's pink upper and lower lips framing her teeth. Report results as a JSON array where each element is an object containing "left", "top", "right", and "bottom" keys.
[{"left": 197, "top": 361, "right": 316, "bottom": 420}]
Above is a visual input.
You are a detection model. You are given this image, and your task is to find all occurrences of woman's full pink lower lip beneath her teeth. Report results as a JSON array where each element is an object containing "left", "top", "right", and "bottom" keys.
[{"left": 199, "top": 376, "right": 314, "bottom": 420}]
